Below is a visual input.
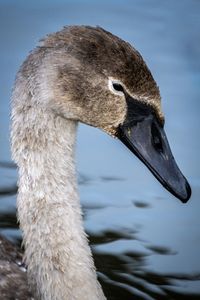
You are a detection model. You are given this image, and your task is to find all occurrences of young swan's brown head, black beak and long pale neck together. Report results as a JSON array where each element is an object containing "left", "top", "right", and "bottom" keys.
[{"left": 11, "top": 26, "right": 190, "bottom": 300}]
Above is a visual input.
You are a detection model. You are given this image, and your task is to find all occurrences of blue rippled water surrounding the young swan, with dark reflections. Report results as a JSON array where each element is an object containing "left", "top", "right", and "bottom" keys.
[{"left": 0, "top": 0, "right": 200, "bottom": 300}]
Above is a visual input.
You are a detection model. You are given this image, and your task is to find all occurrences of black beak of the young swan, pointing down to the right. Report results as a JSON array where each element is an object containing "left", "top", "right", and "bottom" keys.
[{"left": 118, "top": 97, "right": 191, "bottom": 203}]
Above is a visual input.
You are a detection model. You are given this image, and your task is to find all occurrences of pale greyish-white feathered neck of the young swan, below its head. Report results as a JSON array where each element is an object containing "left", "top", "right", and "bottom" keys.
[{"left": 12, "top": 108, "right": 105, "bottom": 300}]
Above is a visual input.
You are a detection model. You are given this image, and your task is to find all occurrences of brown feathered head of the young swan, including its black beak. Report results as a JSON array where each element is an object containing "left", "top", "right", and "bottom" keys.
[{"left": 41, "top": 26, "right": 191, "bottom": 202}]
